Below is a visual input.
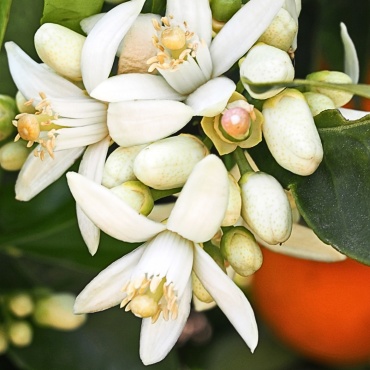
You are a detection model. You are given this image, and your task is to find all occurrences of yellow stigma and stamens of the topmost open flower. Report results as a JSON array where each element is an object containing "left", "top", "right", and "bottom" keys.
[{"left": 147, "top": 16, "right": 199, "bottom": 72}]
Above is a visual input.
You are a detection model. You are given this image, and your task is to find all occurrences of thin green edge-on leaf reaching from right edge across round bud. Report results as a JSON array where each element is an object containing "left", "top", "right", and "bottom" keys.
[{"left": 242, "top": 77, "right": 370, "bottom": 99}]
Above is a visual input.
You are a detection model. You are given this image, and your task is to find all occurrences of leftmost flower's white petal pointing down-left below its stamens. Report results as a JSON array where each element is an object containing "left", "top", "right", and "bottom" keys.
[{"left": 15, "top": 147, "right": 85, "bottom": 201}]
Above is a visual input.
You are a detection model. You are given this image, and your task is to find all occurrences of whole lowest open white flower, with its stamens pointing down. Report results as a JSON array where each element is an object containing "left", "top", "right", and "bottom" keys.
[{"left": 67, "top": 155, "right": 258, "bottom": 365}]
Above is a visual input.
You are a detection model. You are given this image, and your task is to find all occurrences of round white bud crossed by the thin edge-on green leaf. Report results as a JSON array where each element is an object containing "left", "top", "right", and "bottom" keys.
[{"left": 240, "top": 42, "right": 294, "bottom": 99}]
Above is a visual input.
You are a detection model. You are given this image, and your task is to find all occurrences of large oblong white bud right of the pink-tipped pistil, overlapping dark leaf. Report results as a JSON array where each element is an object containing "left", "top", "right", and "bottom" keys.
[{"left": 262, "top": 89, "right": 323, "bottom": 176}]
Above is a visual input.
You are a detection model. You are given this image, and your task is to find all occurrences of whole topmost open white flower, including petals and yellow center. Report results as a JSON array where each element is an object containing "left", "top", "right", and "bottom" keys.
[{"left": 88, "top": 0, "right": 284, "bottom": 146}]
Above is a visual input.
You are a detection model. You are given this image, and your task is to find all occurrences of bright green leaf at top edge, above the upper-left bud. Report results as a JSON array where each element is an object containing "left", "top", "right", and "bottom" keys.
[{"left": 41, "top": 0, "right": 104, "bottom": 33}]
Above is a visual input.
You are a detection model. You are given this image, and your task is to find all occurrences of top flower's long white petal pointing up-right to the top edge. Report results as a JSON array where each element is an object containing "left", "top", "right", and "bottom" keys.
[{"left": 210, "top": 0, "right": 284, "bottom": 77}]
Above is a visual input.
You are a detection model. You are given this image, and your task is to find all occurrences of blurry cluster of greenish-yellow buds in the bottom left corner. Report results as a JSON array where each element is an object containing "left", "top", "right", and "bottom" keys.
[{"left": 0, "top": 289, "right": 86, "bottom": 354}]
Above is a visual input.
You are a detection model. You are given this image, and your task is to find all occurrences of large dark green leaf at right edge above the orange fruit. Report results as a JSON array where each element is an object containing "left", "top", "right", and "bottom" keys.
[{"left": 250, "top": 110, "right": 370, "bottom": 265}]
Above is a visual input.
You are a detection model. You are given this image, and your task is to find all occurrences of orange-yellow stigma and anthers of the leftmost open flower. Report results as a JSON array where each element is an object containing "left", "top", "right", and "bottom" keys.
[{"left": 13, "top": 92, "right": 58, "bottom": 160}]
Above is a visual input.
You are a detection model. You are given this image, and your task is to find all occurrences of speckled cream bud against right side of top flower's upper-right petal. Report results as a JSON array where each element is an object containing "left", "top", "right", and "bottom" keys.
[{"left": 258, "top": 8, "right": 298, "bottom": 51}]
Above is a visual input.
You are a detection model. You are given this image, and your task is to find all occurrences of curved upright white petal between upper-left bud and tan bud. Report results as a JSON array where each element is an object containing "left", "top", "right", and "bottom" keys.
[{"left": 81, "top": 0, "right": 144, "bottom": 93}]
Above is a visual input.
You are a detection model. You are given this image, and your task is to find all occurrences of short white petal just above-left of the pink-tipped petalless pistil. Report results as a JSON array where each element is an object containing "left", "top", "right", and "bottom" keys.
[{"left": 185, "top": 77, "right": 236, "bottom": 117}]
